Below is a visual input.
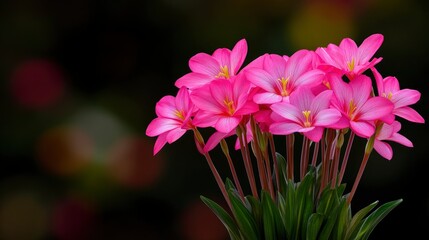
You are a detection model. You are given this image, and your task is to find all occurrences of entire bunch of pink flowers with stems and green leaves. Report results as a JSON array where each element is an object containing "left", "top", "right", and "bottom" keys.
[{"left": 146, "top": 34, "right": 424, "bottom": 239}]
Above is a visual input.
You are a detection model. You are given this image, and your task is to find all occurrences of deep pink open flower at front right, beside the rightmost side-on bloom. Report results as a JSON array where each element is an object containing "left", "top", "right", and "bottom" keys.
[{"left": 329, "top": 74, "right": 393, "bottom": 138}]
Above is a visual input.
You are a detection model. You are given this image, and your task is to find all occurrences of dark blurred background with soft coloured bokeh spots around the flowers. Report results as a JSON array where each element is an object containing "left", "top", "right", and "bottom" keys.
[{"left": 0, "top": 0, "right": 429, "bottom": 240}]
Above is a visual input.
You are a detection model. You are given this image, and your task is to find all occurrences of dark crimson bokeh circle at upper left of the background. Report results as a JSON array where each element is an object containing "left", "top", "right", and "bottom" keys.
[{"left": 10, "top": 59, "right": 65, "bottom": 109}]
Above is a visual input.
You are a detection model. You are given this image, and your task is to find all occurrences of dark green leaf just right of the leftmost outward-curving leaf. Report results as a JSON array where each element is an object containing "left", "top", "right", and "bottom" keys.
[{"left": 228, "top": 189, "right": 259, "bottom": 240}]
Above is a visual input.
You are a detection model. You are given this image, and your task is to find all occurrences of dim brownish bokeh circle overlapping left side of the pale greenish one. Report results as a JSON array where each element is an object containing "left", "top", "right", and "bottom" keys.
[{"left": 36, "top": 126, "right": 93, "bottom": 176}]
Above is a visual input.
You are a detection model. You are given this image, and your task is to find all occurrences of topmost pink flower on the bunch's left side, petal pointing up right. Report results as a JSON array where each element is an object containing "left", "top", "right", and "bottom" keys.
[{"left": 175, "top": 39, "right": 247, "bottom": 89}]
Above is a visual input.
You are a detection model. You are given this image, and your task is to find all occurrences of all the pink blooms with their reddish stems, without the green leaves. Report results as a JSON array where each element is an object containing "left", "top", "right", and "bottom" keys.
[{"left": 146, "top": 34, "right": 424, "bottom": 239}]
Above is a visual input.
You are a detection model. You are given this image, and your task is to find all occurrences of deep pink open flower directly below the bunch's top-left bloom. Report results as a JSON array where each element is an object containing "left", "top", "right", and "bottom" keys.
[{"left": 191, "top": 75, "right": 258, "bottom": 133}]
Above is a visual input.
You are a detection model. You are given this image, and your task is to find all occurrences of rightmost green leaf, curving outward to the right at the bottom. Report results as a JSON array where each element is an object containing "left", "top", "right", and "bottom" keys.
[{"left": 356, "top": 199, "right": 402, "bottom": 240}]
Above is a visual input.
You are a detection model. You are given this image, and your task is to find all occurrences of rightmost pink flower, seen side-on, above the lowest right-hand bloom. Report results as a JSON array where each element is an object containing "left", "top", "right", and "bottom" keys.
[{"left": 371, "top": 68, "right": 425, "bottom": 123}]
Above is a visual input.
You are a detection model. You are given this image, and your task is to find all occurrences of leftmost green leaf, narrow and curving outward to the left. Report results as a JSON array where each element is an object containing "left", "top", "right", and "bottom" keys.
[{"left": 200, "top": 196, "right": 240, "bottom": 240}]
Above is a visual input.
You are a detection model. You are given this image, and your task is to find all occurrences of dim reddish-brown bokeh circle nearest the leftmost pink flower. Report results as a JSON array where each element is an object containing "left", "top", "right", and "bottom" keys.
[{"left": 108, "top": 137, "right": 165, "bottom": 188}]
